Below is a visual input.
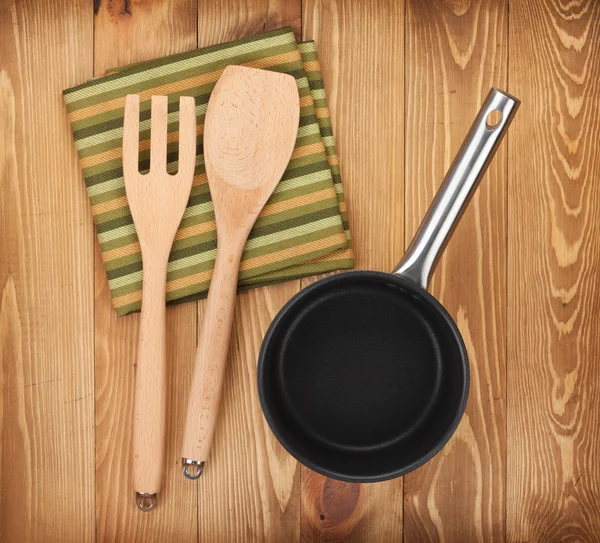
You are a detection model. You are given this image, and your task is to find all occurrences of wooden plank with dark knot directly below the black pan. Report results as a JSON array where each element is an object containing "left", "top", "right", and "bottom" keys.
[{"left": 301, "top": 0, "right": 404, "bottom": 543}]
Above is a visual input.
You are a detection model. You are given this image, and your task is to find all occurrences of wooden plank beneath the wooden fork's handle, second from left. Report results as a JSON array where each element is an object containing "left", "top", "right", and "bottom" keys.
[{"left": 88, "top": 0, "right": 198, "bottom": 541}]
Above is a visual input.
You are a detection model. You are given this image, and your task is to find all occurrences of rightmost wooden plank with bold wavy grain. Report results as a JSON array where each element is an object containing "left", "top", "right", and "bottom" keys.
[{"left": 507, "top": 0, "right": 600, "bottom": 542}]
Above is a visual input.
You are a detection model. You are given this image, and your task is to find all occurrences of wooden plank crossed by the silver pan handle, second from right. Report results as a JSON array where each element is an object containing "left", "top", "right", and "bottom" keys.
[{"left": 404, "top": 0, "right": 507, "bottom": 543}]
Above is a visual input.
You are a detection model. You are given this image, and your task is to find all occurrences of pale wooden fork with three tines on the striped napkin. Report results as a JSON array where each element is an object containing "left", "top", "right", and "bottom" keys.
[{"left": 123, "top": 95, "right": 196, "bottom": 511}]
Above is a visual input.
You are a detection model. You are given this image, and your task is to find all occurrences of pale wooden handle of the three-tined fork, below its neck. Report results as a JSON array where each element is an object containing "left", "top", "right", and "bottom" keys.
[{"left": 133, "top": 260, "right": 167, "bottom": 511}]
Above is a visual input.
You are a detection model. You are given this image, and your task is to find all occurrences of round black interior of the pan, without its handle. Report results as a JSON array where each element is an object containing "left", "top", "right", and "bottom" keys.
[{"left": 259, "top": 273, "right": 468, "bottom": 478}]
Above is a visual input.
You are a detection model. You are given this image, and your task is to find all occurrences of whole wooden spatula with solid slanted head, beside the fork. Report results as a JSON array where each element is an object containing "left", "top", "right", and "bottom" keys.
[{"left": 182, "top": 66, "right": 300, "bottom": 479}]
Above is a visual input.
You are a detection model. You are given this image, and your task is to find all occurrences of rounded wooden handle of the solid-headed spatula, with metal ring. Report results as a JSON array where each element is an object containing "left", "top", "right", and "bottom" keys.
[{"left": 181, "top": 240, "right": 245, "bottom": 479}]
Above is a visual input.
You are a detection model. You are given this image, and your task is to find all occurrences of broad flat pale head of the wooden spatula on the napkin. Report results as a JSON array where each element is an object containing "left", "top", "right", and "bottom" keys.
[{"left": 204, "top": 66, "right": 300, "bottom": 201}]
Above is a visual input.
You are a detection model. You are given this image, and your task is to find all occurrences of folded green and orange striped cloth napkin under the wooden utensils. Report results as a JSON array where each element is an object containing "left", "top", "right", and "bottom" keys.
[{"left": 63, "top": 28, "right": 354, "bottom": 315}]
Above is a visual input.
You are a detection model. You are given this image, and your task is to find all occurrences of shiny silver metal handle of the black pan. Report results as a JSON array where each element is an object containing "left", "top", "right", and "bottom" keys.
[{"left": 392, "top": 89, "right": 520, "bottom": 289}]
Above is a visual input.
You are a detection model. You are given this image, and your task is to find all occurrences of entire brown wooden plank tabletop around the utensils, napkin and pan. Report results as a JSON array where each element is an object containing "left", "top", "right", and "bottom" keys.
[{"left": 0, "top": 0, "right": 600, "bottom": 543}]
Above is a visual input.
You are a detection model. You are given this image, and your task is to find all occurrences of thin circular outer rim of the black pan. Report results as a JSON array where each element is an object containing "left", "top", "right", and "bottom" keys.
[{"left": 257, "top": 270, "right": 470, "bottom": 483}]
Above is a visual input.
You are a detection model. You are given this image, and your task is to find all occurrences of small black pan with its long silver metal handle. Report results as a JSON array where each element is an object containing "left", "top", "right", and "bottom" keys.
[{"left": 258, "top": 89, "right": 520, "bottom": 482}]
